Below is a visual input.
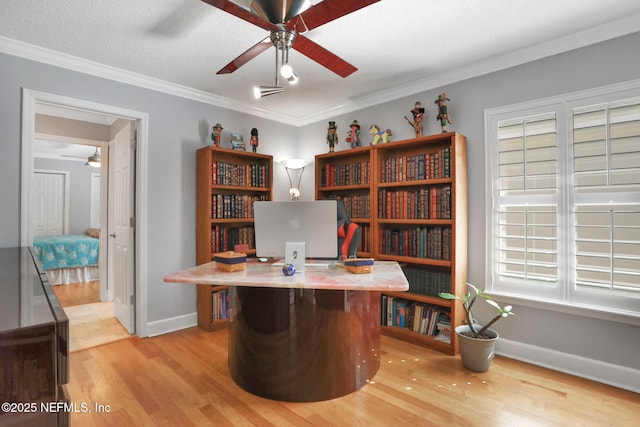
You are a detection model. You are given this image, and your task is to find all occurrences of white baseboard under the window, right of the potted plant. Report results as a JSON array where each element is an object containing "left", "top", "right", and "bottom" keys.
[{"left": 496, "top": 338, "right": 640, "bottom": 393}]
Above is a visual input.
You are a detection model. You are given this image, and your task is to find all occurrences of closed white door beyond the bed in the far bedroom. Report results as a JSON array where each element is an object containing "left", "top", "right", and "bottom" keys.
[{"left": 33, "top": 171, "right": 67, "bottom": 237}]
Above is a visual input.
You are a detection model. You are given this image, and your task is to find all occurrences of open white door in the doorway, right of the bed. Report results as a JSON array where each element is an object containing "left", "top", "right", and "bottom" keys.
[{"left": 108, "top": 121, "right": 135, "bottom": 334}]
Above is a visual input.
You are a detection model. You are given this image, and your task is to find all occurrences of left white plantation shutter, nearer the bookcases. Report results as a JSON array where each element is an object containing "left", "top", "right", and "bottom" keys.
[{"left": 497, "top": 114, "right": 558, "bottom": 286}]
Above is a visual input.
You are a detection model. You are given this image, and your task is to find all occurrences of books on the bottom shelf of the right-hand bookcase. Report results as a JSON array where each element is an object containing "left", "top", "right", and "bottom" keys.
[{"left": 380, "top": 295, "right": 451, "bottom": 335}]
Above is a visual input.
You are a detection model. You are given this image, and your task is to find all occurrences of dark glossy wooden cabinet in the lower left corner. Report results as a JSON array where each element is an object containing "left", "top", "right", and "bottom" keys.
[{"left": 0, "top": 248, "right": 70, "bottom": 426}]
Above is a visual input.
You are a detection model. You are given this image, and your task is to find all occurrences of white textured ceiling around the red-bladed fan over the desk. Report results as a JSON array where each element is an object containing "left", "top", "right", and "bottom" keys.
[{"left": 0, "top": 0, "right": 640, "bottom": 125}]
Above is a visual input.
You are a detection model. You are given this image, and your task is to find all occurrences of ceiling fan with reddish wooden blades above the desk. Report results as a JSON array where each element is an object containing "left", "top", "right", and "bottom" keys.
[{"left": 202, "top": 0, "right": 379, "bottom": 77}]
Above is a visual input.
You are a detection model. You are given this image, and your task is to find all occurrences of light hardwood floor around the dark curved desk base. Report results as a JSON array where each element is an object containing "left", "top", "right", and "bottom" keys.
[{"left": 68, "top": 328, "right": 640, "bottom": 427}]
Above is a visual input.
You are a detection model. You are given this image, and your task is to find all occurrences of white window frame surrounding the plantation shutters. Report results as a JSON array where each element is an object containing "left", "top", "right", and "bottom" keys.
[{"left": 484, "top": 80, "right": 640, "bottom": 325}]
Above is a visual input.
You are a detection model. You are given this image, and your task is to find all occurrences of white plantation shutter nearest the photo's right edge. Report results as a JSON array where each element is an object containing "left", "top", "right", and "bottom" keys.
[{"left": 573, "top": 99, "right": 640, "bottom": 295}]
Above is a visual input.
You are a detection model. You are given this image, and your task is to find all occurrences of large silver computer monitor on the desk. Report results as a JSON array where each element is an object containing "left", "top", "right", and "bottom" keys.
[{"left": 253, "top": 200, "right": 338, "bottom": 271}]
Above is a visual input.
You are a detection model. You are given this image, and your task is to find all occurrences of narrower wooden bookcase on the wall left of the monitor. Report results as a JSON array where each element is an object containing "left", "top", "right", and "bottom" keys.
[{"left": 196, "top": 146, "right": 273, "bottom": 331}]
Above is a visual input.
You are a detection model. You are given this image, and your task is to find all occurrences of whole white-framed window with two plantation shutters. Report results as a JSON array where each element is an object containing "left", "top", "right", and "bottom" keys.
[{"left": 486, "top": 82, "right": 640, "bottom": 317}]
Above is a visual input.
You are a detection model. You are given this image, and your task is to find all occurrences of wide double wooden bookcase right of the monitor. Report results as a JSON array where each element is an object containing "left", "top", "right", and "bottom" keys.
[{"left": 316, "top": 132, "right": 467, "bottom": 354}]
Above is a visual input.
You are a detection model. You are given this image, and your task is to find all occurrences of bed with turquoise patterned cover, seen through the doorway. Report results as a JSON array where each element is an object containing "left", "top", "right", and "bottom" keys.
[{"left": 33, "top": 234, "right": 100, "bottom": 285}]
